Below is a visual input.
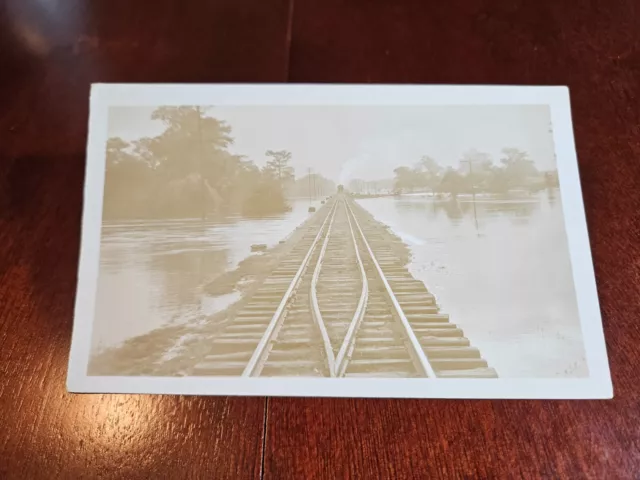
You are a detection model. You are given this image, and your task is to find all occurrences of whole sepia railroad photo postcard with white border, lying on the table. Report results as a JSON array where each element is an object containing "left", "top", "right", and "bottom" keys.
[{"left": 67, "top": 84, "right": 613, "bottom": 398}]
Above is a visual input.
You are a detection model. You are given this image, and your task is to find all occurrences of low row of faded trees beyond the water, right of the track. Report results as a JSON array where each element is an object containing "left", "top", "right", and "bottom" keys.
[{"left": 394, "top": 148, "right": 558, "bottom": 197}]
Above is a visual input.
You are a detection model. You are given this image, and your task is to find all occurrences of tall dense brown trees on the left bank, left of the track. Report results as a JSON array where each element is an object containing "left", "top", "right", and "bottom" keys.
[{"left": 104, "top": 106, "right": 295, "bottom": 217}]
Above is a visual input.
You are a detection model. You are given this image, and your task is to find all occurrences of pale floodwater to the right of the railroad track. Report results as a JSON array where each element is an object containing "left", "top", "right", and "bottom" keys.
[{"left": 358, "top": 191, "right": 588, "bottom": 378}]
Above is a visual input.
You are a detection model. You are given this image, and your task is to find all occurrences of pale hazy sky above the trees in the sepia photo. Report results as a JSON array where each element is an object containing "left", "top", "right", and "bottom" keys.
[{"left": 109, "top": 105, "right": 555, "bottom": 183}]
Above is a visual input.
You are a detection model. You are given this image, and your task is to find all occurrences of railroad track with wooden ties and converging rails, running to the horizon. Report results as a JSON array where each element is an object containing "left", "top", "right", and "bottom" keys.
[{"left": 194, "top": 195, "right": 497, "bottom": 378}]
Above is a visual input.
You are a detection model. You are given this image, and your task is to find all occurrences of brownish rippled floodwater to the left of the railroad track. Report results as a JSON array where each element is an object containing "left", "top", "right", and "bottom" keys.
[{"left": 92, "top": 200, "right": 319, "bottom": 353}]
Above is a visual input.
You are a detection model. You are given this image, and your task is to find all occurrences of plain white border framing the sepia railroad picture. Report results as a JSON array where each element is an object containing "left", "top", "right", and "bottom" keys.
[{"left": 67, "top": 84, "right": 613, "bottom": 399}]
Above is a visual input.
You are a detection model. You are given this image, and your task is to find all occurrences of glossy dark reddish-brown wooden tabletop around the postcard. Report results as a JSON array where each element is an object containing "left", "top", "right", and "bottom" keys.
[{"left": 0, "top": 0, "right": 640, "bottom": 479}]
